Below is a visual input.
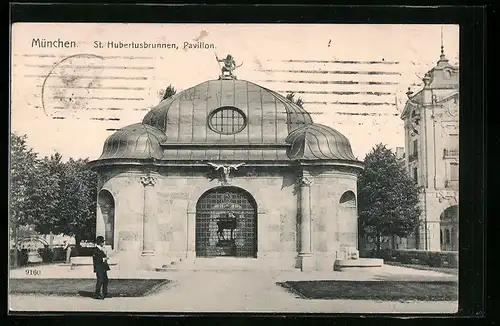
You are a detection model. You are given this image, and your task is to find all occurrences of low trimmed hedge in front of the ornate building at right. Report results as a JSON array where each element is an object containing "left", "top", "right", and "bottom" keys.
[{"left": 368, "top": 249, "right": 458, "bottom": 268}]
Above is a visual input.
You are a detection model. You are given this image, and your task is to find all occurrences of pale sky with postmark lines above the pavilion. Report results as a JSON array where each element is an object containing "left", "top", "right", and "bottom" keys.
[{"left": 11, "top": 23, "right": 459, "bottom": 159}]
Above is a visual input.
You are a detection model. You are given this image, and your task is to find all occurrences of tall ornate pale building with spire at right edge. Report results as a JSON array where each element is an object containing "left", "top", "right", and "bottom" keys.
[{"left": 401, "top": 46, "right": 459, "bottom": 251}]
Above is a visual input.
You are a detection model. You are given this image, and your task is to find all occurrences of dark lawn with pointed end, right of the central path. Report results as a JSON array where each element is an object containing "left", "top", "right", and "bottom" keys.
[{"left": 277, "top": 280, "right": 458, "bottom": 301}]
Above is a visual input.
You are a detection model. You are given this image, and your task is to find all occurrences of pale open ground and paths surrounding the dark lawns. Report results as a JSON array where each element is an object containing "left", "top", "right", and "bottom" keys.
[{"left": 9, "top": 266, "right": 458, "bottom": 313}]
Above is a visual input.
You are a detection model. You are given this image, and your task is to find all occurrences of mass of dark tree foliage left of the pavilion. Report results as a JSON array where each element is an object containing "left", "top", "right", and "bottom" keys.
[{"left": 9, "top": 134, "right": 97, "bottom": 244}]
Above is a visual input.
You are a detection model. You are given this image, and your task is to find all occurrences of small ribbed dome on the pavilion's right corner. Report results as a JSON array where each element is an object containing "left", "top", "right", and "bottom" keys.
[{"left": 285, "top": 123, "right": 357, "bottom": 161}]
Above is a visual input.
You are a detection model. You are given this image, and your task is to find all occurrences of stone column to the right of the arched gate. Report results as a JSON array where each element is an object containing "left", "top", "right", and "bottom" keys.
[{"left": 298, "top": 174, "right": 315, "bottom": 272}]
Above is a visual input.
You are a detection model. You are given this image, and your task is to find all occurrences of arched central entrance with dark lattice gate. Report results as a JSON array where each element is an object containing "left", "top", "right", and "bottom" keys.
[{"left": 196, "top": 187, "right": 257, "bottom": 257}]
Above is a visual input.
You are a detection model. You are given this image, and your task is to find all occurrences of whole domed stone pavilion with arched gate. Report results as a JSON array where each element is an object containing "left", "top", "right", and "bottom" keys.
[{"left": 90, "top": 69, "right": 363, "bottom": 271}]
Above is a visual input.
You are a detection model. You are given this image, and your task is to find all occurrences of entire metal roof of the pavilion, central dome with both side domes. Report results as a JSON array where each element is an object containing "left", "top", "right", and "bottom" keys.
[{"left": 93, "top": 79, "right": 362, "bottom": 165}]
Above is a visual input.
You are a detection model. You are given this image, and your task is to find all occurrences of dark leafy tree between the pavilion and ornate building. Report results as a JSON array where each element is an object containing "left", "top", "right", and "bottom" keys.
[{"left": 358, "top": 144, "right": 421, "bottom": 251}]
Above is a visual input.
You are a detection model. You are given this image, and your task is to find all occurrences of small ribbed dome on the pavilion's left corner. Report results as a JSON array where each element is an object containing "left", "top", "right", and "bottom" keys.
[{"left": 99, "top": 123, "right": 167, "bottom": 160}]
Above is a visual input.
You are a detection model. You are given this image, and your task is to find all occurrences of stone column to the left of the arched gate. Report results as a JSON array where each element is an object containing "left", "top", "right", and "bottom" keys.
[{"left": 141, "top": 175, "right": 157, "bottom": 256}]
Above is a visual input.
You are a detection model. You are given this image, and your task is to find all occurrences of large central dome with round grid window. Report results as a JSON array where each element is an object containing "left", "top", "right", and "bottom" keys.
[{"left": 142, "top": 79, "right": 313, "bottom": 145}]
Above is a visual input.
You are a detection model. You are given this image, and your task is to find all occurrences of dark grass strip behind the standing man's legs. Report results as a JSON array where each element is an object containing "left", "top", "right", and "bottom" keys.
[{"left": 9, "top": 279, "right": 170, "bottom": 297}]
